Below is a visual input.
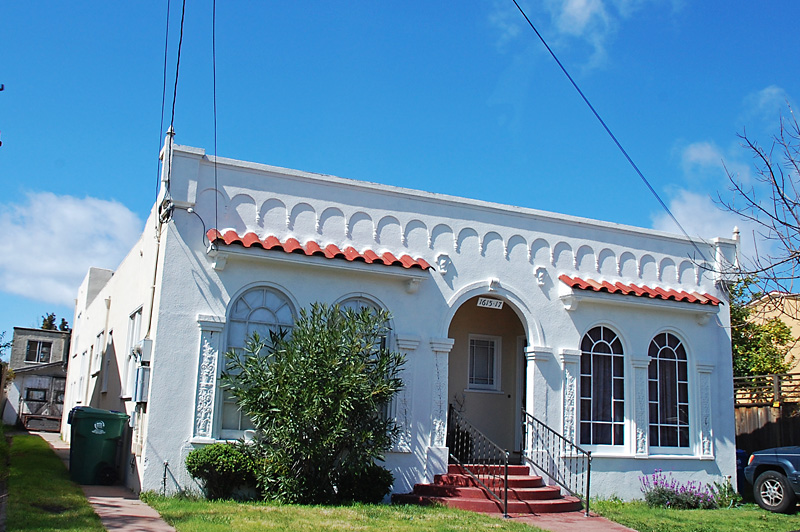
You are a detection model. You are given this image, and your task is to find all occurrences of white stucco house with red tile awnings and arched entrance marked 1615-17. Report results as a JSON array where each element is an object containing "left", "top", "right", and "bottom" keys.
[{"left": 62, "top": 136, "right": 738, "bottom": 498}]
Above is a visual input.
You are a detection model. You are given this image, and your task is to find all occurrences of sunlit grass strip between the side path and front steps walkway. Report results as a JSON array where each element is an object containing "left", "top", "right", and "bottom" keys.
[{"left": 142, "top": 493, "right": 540, "bottom": 532}]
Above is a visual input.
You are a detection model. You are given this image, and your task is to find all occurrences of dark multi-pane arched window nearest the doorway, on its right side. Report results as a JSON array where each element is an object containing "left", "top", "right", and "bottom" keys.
[{"left": 580, "top": 325, "right": 625, "bottom": 445}]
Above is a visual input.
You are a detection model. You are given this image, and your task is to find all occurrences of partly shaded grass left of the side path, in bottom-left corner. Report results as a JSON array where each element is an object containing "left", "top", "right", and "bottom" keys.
[{"left": 6, "top": 434, "right": 105, "bottom": 532}]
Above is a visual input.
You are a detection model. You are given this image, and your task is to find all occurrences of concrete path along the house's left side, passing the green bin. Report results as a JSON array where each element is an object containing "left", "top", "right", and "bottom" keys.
[{"left": 31, "top": 432, "right": 175, "bottom": 532}]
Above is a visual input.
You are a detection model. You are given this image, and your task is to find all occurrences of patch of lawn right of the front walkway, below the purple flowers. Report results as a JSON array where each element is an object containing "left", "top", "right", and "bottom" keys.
[{"left": 592, "top": 501, "right": 800, "bottom": 532}]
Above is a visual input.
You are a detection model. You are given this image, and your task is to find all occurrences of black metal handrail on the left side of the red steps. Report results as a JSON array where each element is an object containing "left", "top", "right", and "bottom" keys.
[{"left": 447, "top": 405, "right": 508, "bottom": 517}]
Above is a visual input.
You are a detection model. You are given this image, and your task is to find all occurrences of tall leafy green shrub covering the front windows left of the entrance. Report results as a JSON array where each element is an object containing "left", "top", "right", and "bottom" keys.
[{"left": 221, "top": 303, "right": 404, "bottom": 504}]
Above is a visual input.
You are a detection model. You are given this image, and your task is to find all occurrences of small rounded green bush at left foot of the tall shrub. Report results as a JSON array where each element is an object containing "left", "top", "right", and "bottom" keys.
[{"left": 186, "top": 443, "right": 256, "bottom": 500}]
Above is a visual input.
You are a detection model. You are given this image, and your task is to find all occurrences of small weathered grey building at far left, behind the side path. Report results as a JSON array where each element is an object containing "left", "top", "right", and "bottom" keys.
[{"left": 3, "top": 327, "right": 70, "bottom": 431}]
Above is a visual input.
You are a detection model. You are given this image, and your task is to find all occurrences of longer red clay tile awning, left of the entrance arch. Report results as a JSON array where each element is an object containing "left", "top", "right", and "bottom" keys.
[{"left": 206, "top": 229, "right": 431, "bottom": 270}]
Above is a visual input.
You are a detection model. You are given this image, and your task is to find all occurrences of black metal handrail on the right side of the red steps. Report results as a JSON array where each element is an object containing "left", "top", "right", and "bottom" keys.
[{"left": 522, "top": 410, "right": 592, "bottom": 515}]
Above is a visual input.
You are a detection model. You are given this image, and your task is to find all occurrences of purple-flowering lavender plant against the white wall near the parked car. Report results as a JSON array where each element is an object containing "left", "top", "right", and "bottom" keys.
[{"left": 639, "top": 469, "right": 717, "bottom": 510}]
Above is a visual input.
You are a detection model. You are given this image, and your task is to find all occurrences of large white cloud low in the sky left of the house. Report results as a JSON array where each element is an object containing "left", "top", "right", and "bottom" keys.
[{"left": 0, "top": 192, "right": 142, "bottom": 306}]
